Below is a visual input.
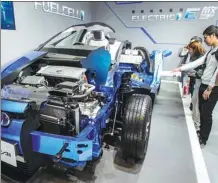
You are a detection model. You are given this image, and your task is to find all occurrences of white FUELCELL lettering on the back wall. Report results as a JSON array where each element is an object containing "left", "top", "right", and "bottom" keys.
[{"left": 34, "top": 2, "right": 85, "bottom": 20}]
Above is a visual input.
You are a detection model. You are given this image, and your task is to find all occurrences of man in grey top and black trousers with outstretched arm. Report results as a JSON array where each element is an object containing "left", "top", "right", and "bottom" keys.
[{"left": 174, "top": 25, "right": 218, "bottom": 147}]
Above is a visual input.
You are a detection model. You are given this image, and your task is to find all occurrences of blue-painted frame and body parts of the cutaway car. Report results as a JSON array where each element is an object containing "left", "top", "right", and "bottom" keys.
[{"left": 1, "top": 24, "right": 172, "bottom": 170}]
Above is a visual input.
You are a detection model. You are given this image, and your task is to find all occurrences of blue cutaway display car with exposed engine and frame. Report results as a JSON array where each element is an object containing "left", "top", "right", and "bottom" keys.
[{"left": 1, "top": 22, "right": 171, "bottom": 179}]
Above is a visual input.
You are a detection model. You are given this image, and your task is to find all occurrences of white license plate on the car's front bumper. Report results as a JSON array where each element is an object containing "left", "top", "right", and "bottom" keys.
[{"left": 1, "top": 140, "right": 17, "bottom": 167}]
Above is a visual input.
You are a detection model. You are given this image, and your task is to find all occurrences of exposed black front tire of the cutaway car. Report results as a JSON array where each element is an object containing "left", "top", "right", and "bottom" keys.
[{"left": 121, "top": 94, "right": 152, "bottom": 161}]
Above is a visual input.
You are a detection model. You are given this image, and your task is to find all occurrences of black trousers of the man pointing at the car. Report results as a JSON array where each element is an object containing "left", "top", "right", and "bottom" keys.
[{"left": 198, "top": 84, "right": 218, "bottom": 142}]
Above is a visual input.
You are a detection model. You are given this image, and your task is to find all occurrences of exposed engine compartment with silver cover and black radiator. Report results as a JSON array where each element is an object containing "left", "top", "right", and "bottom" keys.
[{"left": 1, "top": 58, "right": 106, "bottom": 136}]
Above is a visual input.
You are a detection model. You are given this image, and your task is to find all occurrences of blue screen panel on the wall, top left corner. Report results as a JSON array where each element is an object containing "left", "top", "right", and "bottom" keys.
[{"left": 1, "top": 1, "right": 15, "bottom": 30}]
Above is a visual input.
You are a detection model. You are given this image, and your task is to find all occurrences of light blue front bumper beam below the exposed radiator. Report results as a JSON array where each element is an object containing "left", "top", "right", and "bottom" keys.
[{"left": 31, "top": 131, "right": 93, "bottom": 161}]
